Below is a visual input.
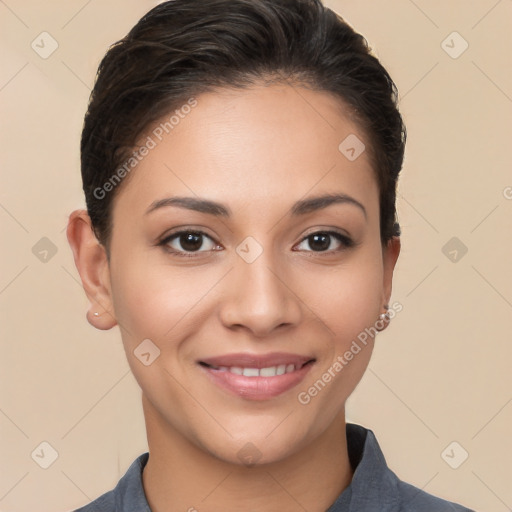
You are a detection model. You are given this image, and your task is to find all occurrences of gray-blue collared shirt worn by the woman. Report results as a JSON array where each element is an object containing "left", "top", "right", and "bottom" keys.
[{"left": 74, "top": 423, "right": 473, "bottom": 512}]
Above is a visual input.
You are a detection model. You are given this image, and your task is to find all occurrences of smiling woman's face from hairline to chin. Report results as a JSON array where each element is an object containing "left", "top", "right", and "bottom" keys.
[{"left": 104, "top": 85, "right": 398, "bottom": 463}]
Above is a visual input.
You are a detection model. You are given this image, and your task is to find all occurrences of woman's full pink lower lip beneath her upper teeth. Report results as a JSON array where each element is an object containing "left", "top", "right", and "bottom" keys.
[{"left": 200, "top": 363, "right": 313, "bottom": 400}]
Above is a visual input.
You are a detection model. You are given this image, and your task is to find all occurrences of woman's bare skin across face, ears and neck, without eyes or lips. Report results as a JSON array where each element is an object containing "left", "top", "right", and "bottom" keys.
[{"left": 67, "top": 84, "right": 400, "bottom": 512}]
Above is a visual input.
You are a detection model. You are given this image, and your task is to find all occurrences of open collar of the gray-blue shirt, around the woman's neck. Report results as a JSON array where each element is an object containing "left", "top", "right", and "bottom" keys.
[{"left": 114, "top": 423, "right": 399, "bottom": 512}]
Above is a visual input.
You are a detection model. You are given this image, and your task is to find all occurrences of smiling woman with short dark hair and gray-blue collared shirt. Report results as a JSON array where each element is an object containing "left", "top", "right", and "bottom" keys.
[{"left": 67, "top": 0, "right": 476, "bottom": 512}]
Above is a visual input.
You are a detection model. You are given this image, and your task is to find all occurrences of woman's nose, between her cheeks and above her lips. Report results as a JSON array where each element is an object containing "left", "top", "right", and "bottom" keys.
[{"left": 220, "top": 251, "right": 303, "bottom": 337}]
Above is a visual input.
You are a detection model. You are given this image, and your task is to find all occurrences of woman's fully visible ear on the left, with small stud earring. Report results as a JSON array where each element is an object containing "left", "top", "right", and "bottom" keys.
[{"left": 66, "top": 210, "right": 117, "bottom": 330}]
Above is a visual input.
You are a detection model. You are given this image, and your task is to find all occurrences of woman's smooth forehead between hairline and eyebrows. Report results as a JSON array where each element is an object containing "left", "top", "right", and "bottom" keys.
[{"left": 112, "top": 84, "right": 378, "bottom": 220}]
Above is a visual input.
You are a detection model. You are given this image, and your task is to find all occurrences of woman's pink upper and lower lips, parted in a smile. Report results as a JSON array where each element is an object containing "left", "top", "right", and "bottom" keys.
[{"left": 198, "top": 352, "right": 316, "bottom": 401}]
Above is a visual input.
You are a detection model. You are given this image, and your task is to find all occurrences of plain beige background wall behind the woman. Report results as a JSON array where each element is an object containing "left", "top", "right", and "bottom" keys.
[{"left": 0, "top": 0, "right": 512, "bottom": 512}]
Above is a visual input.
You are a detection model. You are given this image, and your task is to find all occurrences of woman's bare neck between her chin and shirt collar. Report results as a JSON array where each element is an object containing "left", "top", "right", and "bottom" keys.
[{"left": 142, "top": 395, "right": 353, "bottom": 512}]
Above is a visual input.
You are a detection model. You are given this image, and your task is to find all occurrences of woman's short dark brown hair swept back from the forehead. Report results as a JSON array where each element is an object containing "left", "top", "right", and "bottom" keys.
[{"left": 81, "top": 0, "right": 406, "bottom": 251}]
